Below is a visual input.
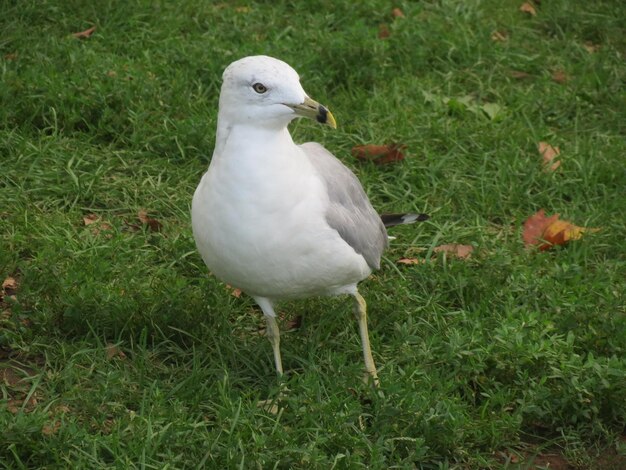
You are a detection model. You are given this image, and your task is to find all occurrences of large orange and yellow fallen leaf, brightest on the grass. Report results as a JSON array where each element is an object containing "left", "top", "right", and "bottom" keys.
[{"left": 522, "top": 209, "right": 600, "bottom": 251}]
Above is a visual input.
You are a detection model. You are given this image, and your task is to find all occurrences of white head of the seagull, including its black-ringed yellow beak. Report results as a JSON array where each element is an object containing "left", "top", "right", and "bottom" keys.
[{"left": 220, "top": 56, "right": 336, "bottom": 129}]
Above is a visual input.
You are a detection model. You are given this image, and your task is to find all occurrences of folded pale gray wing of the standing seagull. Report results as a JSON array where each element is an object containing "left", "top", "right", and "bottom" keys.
[{"left": 300, "top": 142, "right": 388, "bottom": 269}]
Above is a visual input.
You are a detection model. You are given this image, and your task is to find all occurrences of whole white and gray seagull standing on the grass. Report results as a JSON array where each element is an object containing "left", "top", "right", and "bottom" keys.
[{"left": 191, "top": 56, "right": 426, "bottom": 385}]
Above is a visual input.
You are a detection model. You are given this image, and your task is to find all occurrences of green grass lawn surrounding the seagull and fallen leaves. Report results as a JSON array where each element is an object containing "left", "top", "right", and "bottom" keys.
[{"left": 0, "top": 0, "right": 626, "bottom": 469}]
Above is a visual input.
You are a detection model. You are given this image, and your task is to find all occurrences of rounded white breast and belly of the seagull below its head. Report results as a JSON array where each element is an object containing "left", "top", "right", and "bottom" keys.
[{"left": 192, "top": 126, "right": 370, "bottom": 299}]
